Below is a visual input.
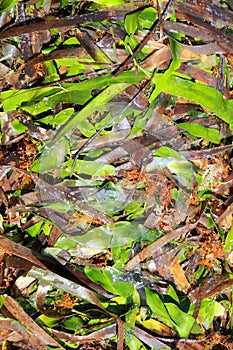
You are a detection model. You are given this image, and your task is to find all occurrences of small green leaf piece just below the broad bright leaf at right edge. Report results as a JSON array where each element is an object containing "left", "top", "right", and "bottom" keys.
[{"left": 178, "top": 123, "right": 221, "bottom": 144}]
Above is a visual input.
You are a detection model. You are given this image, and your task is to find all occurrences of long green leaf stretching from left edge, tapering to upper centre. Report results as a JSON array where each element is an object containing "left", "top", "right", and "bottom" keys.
[{"left": 0, "top": 71, "right": 145, "bottom": 115}]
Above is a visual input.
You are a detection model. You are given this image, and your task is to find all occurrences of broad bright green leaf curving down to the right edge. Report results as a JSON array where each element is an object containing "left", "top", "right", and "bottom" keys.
[{"left": 150, "top": 75, "right": 233, "bottom": 129}]
